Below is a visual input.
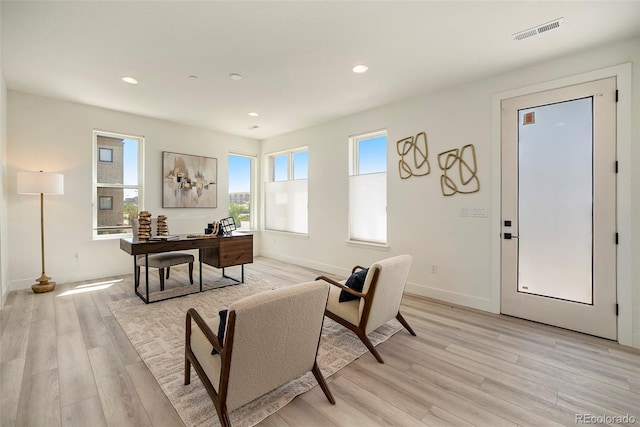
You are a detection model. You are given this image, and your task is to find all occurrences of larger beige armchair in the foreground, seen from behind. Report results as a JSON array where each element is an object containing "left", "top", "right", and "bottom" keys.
[{"left": 184, "top": 281, "right": 335, "bottom": 426}]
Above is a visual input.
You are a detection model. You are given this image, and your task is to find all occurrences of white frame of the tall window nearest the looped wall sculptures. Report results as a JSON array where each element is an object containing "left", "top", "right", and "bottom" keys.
[{"left": 347, "top": 129, "right": 389, "bottom": 248}]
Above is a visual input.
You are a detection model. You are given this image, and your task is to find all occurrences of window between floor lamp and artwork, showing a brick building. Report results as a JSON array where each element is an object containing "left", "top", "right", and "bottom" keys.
[{"left": 93, "top": 131, "right": 144, "bottom": 239}]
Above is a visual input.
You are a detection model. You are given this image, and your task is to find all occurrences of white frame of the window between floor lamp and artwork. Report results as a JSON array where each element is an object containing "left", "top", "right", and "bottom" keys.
[{"left": 91, "top": 129, "right": 145, "bottom": 240}]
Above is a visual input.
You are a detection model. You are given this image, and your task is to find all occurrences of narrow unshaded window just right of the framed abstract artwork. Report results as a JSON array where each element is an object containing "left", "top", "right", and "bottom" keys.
[{"left": 229, "top": 154, "right": 255, "bottom": 230}]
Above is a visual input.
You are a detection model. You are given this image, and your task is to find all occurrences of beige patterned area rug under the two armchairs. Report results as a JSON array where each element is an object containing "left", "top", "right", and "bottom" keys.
[{"left": 109, "top": 274, "right": 401, "bottom": 427}]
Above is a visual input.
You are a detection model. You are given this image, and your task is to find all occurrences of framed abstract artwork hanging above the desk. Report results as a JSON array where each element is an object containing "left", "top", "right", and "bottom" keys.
[{"left": 162, "top": 151, "right": 218, "bottom": 208}]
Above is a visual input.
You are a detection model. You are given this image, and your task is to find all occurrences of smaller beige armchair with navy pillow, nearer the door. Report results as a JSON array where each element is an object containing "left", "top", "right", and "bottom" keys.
[{"left": 318, "top": 255, "right": 416, "bottom": 363}]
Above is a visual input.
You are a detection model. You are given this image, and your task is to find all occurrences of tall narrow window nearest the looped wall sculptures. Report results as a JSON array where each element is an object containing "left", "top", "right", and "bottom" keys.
[{"left": 349, "top": 131, "right": 387, "bottom": 245}]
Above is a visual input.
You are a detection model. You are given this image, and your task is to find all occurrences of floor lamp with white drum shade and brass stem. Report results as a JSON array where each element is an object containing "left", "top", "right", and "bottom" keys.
[{"left": 18, "top": 171, "right": 64, "bottom": 293}]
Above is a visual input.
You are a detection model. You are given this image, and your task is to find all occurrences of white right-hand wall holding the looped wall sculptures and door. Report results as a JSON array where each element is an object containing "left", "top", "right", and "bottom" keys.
[{"left": 261, "top": 38, "right": 640, "bottom": 347}]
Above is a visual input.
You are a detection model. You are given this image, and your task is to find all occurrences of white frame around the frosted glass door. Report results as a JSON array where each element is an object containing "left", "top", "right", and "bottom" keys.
[{"left": 491, "top": 63, "right": 633, "bottom": 352}]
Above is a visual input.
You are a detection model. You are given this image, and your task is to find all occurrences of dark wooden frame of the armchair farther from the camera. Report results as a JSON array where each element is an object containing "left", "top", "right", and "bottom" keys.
[{"left": 316, "top": 265, "right": 416, "bottom": 363}]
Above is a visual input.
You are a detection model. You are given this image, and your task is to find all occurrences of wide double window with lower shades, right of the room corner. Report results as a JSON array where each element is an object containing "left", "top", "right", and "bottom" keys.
[{"left": 265, "top": 148, "right": 309, "bottom": 234}]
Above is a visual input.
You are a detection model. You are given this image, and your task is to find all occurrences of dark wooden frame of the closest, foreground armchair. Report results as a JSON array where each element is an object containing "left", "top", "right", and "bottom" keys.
[{"left": 184, "top": 308, "right": 336, "bottom": 427}]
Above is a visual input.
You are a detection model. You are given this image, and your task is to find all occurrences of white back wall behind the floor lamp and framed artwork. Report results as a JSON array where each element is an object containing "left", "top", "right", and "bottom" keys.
[{"left": 3, "top": 91, "right": 259, "bottom": 290}]
